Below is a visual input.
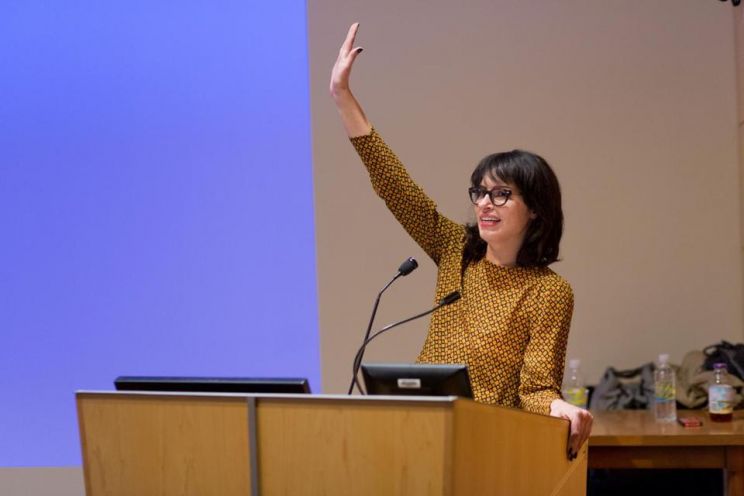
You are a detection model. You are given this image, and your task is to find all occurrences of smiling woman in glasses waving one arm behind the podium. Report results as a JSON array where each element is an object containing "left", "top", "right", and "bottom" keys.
[{"left": 330, "top": 24, "right": 592, "bottom": 458}]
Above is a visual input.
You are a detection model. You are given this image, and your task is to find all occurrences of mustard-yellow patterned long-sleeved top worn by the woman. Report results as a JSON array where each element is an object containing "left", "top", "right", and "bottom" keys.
[{"left": 351, "top": 129, "right": 573, "bottom": 414}]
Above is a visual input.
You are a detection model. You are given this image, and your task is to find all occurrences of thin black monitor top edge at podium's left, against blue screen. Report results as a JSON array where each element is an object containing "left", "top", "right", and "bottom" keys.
[{"left": 114, "top": 376, "right": 310, "bottom": 394}]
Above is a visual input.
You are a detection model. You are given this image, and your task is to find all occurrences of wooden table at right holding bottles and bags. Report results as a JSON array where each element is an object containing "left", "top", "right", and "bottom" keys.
[{"left": 589, "top": 410, "right": 744, "bottom": 496}]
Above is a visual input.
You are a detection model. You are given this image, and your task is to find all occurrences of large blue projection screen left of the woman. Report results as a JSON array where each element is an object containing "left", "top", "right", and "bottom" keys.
[{"left": 0, "top": 0, "right": 320, "bottom": 466}]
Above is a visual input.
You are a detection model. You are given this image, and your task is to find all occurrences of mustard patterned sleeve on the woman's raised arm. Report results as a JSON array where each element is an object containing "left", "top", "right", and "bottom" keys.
[{"left": 351, "top": 128, "right": 464, "bottom": 264}]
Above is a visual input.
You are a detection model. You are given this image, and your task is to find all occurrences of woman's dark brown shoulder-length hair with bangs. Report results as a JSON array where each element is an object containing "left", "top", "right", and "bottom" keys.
[{"left": 462, "top": 150, "right": 563, "bottom": 271}]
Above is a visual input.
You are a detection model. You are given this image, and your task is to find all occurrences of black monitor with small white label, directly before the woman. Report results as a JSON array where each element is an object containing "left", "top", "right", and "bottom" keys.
[{"left": 362, "top": 363, "right": 473, "bottom": 398}]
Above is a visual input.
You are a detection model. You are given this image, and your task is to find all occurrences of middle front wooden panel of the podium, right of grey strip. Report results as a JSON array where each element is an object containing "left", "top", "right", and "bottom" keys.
[{"left": 257, "top": 399, "right": 452, "bottom": 496}]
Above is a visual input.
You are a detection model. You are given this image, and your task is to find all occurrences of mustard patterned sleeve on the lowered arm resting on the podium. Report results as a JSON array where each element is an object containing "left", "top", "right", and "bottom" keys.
[{"left": 519, "top": 278, "right": 574, "bottom": 414}]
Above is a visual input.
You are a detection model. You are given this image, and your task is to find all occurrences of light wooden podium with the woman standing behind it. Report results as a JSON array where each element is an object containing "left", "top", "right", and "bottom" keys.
[{"left": 76, "top": 392, "right": 587, "bottom": 496}]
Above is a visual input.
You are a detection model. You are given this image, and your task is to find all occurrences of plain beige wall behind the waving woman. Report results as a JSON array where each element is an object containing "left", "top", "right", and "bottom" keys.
[{"left": 308, "top": 0, "right": 742, "bottom": 392}]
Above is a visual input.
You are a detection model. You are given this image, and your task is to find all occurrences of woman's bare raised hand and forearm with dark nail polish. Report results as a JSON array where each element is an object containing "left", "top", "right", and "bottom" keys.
[{"left": 329, "top": 22, "right": 372, "bottom": 138}]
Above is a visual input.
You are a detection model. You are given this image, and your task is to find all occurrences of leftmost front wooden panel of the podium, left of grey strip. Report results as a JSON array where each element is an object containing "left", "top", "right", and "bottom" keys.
[{"left": 77, "top": 394, "right": 251, "bottom": 496}]
